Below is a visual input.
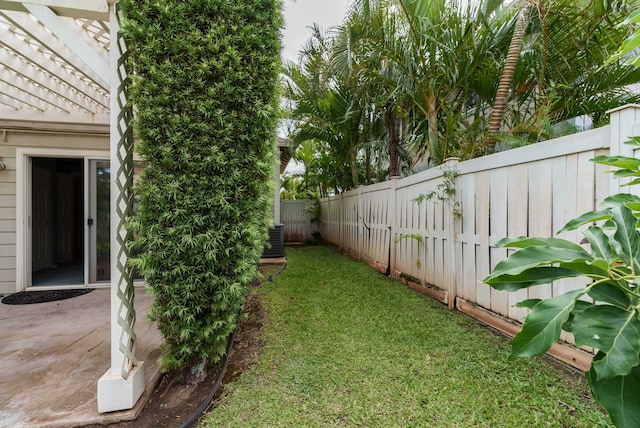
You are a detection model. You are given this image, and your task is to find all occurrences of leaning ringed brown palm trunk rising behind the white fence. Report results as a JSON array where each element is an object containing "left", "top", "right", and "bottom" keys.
[{"left": 485, "top": 0, "right": 529, "bottom": 151}]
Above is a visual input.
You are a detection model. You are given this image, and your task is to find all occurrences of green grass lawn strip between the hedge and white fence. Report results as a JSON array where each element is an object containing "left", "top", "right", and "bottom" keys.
[{"left": 201, "top": 247, "right": 609, "bottom": 428}]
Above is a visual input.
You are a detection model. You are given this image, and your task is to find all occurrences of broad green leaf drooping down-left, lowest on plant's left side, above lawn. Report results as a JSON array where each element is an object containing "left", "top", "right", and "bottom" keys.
[{"left": 511, "top": 290, "right": 584, "bottom": 358}]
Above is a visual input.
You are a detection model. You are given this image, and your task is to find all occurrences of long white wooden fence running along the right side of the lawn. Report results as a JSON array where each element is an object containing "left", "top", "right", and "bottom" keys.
[{"left": 308, "top": 106, "right": 640, "bottom": 368}]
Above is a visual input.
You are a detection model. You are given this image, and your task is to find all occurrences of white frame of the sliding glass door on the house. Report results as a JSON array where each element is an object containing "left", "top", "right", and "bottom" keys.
[{"left": 16, "top": 147, "right": 110, "bottom": 292}]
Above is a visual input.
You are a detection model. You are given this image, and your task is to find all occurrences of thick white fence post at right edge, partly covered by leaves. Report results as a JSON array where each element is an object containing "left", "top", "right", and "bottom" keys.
[{"left": 607, "top": 104, "right": 640, "bottom": 195}]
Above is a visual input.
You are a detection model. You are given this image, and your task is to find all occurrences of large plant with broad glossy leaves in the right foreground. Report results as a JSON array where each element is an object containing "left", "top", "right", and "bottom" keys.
[{"left": 484, "top": 137, "right": 640, "bottom": 427}]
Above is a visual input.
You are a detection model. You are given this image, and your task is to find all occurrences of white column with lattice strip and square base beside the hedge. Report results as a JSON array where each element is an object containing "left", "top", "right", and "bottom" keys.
[{"left": 98, "top": 0, "right": 144, "bottom": 413}]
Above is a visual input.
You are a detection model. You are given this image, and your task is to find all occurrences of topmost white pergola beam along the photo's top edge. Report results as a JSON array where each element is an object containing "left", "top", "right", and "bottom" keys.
[{"left": 0, "top": 0, "right": 109, "bottom": 21}]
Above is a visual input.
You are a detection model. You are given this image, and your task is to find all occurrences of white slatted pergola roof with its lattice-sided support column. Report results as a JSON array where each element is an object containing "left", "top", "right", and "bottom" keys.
[{"left": 0, "top": 0, "right": 144, "bottom": 412}]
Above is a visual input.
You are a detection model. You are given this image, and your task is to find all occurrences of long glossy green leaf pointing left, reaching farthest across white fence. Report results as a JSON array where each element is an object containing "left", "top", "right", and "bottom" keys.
[{"left": 484, "top": 246, "right": 593, "bottom": 284}]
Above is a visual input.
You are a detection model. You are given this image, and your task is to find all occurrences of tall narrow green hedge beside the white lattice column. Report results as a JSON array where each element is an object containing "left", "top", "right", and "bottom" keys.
[{"left": 121, "top": 0, "right": 282, "bottom": 370}]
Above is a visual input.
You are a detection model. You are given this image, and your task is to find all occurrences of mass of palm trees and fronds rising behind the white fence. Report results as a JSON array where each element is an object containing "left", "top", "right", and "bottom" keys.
[{"left": 284, "top": 0, "right": 640, "bottom": 191}]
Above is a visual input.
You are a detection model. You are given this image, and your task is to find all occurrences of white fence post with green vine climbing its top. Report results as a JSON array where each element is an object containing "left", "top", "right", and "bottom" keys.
[{"left": 443, "top": 158, "right": 460, "bottom": 309}]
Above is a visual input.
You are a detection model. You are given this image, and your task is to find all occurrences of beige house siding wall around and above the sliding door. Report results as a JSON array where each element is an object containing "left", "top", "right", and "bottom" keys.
[{"left": 0, "top": 121, "right": 109, "bottom": 295}]
